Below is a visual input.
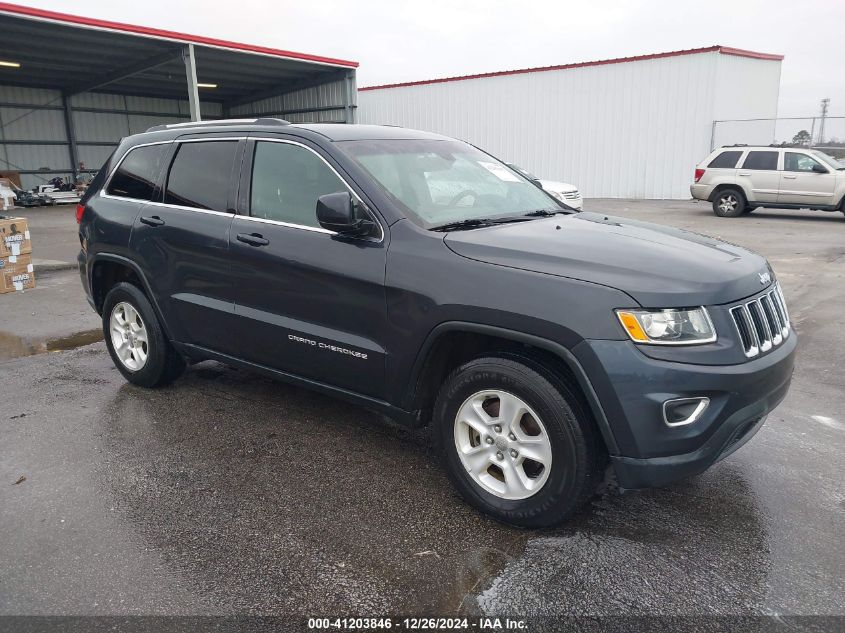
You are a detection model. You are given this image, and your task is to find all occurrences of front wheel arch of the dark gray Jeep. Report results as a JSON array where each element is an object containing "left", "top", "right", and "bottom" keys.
[{"left": 403, "top": 321, "right": 619, "bottom": 455}]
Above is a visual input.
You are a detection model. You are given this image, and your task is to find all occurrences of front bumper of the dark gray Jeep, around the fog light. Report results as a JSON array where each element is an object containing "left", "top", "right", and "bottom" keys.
[{"left": 573, "top": 331, "right": 798, "bottom": 488}]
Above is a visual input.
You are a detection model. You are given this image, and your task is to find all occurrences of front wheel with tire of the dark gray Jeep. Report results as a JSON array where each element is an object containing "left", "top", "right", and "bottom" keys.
[{"left": 434, "top": 356, "right": 602, "bottom": 527}]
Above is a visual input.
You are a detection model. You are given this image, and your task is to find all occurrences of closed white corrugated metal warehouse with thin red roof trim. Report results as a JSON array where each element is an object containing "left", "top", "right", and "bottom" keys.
[{"left": 358, "top": 46, "right": 783, "bottom": 199}]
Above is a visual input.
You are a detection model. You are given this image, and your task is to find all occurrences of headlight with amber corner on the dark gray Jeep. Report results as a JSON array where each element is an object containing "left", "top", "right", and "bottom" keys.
[{"left": 616, "top": 307, "right": 716, "bottom": 345}]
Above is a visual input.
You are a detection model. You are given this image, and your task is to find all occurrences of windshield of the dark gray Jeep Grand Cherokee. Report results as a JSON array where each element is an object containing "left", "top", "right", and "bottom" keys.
[{"left": 338, "top": 139, "right": 565, "bottom": 229}]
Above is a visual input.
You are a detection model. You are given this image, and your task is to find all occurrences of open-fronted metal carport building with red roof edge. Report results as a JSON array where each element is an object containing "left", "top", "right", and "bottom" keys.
[{"left": 0, "top": 3, "right": 358, "bottom": 189}]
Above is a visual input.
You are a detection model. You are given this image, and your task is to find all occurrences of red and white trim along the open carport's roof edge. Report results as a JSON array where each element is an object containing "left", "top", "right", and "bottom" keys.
[{"left": 0, "top": 2, "right": 358, "bottom": 68}]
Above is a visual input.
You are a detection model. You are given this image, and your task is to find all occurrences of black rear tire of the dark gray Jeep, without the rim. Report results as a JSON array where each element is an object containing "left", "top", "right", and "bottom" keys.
[{"left": 102, "top": 282, "right": 185, "bottom": 387}]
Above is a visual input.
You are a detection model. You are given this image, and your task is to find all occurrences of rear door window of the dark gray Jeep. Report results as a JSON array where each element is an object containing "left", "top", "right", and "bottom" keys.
[{"left": 164, "top": 141, "right": 238, "bottom": 212}]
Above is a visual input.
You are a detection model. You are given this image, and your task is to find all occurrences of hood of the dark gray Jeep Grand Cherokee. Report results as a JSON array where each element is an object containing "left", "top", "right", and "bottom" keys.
[{"left": 445, "top": 213, "right": 774, "bottom": 308}]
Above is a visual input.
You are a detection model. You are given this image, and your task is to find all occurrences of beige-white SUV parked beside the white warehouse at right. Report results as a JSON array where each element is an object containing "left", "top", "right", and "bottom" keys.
[{"left": 690, "top": 145, "right": 845, "bottom": 218}]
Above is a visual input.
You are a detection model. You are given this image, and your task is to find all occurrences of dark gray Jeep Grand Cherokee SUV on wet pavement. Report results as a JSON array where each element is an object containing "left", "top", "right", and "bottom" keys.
[{"left": 77, "top": 119, "right": 797, "bottom": 526}]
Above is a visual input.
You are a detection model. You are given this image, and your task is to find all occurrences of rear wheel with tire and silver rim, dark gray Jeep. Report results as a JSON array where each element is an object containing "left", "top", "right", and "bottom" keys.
[{"left": 102, "top": 283, "right": 185, "bottom": 387}]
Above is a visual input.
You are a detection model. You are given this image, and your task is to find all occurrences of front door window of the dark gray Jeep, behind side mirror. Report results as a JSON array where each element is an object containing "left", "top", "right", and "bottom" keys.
[{"left": 250, "top": 141, "right": 347, "bottom": 227}]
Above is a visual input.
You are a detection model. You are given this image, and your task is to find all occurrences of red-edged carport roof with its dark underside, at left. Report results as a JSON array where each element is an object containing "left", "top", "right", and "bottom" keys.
[{"left": 0, "top": 2, "right": 358, "bottom": 105}]
